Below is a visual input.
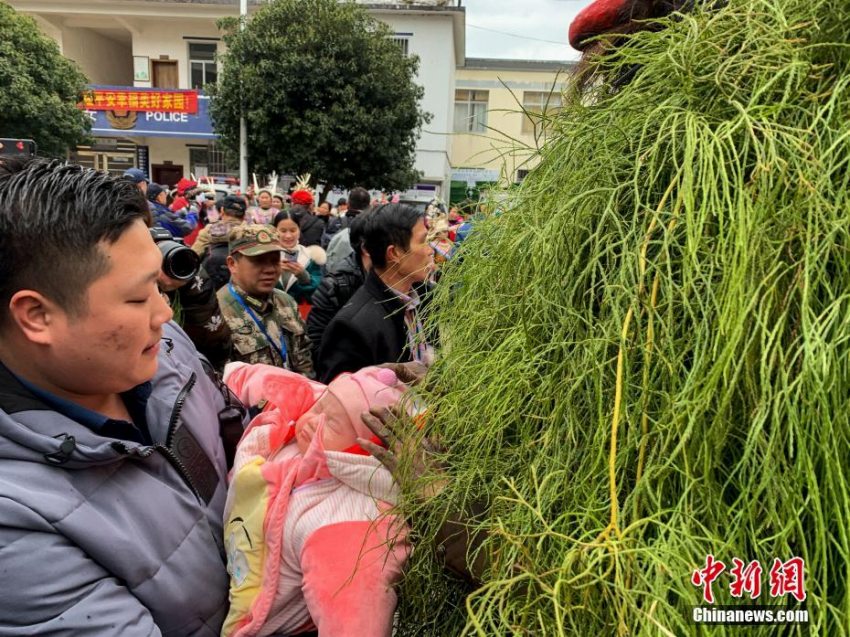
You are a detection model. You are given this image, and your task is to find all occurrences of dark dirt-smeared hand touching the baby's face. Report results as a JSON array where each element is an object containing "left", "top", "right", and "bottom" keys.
[{"left": 357, "top": 407, "right": 447, "bottom": 500}]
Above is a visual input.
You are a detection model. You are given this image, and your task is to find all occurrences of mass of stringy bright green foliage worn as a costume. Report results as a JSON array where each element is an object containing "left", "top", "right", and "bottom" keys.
[{"left": 398, "top": 0, "right": 850, "bottom": 636}]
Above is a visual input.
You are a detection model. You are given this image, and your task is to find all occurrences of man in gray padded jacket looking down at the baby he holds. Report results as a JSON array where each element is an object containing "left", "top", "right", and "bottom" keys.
[{"left": 0, "top": 160, "right": 228, "bottom": 637}]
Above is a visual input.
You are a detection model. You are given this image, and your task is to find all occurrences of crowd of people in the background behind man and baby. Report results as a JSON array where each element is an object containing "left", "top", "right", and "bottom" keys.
[{"left": 134, "top": 169, "right": 464, "bottom": 382}]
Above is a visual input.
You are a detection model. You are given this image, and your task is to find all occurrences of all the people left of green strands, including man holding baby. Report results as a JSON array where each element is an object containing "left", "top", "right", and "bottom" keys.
[{"left": 0, "top": 159, "right": 476, "bottom": 636}]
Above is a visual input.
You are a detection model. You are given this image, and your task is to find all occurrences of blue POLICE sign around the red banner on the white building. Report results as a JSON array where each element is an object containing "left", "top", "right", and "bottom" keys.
[{"left": 85, "top": 84, "right": 216, "bottom": 139}]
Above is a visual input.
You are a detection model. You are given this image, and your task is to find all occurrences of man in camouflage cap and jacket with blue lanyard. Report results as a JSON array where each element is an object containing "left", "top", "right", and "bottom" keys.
[{"left": 216, "top": 224, "right": 315, "bottom": 378}]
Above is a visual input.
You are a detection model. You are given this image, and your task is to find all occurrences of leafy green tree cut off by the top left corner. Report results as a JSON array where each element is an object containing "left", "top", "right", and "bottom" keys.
[{"left": 0, "top": 2, "right": 91, "bottom": 157}]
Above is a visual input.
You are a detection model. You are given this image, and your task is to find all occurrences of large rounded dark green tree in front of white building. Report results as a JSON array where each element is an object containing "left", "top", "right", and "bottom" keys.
[{"left": 208, "top": 0, "right": 430, "bottom": 191}]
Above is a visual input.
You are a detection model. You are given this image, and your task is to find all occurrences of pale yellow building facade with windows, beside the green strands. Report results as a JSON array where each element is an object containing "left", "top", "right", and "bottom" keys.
[{"left": 449, "top": 58, "right": 573, "bottom": 202}]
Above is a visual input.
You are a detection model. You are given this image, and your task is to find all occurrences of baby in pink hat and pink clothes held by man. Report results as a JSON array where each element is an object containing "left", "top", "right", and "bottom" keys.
[{"left": 222, "top": 363, "right": 410, "bottom": 637}]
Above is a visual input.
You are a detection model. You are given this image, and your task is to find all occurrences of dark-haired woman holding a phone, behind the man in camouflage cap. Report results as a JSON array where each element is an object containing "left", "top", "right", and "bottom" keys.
[{"left": 272, "top": 210, "right": 327, "bottom": 318}]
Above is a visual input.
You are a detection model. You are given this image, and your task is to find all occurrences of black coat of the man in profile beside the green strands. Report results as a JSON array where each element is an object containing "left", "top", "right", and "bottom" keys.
[{"left": 317, "top": 271, "right": 427, "bottom": 383}]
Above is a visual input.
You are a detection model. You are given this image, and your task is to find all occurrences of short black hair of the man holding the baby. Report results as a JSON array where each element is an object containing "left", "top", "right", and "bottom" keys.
[{"left": 0, "top": 159, "right": 149, "bottom": 326}]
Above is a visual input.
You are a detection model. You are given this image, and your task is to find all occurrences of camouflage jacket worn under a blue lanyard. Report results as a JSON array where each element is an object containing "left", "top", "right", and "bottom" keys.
[{"left": 216, "top": 284, "right": 315, "bottom": 378}]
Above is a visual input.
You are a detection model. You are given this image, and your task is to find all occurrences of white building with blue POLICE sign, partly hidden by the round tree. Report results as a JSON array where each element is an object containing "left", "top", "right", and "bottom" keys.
[{"left": 10, "top": 0, "right": 465, "bottom": 195}]
